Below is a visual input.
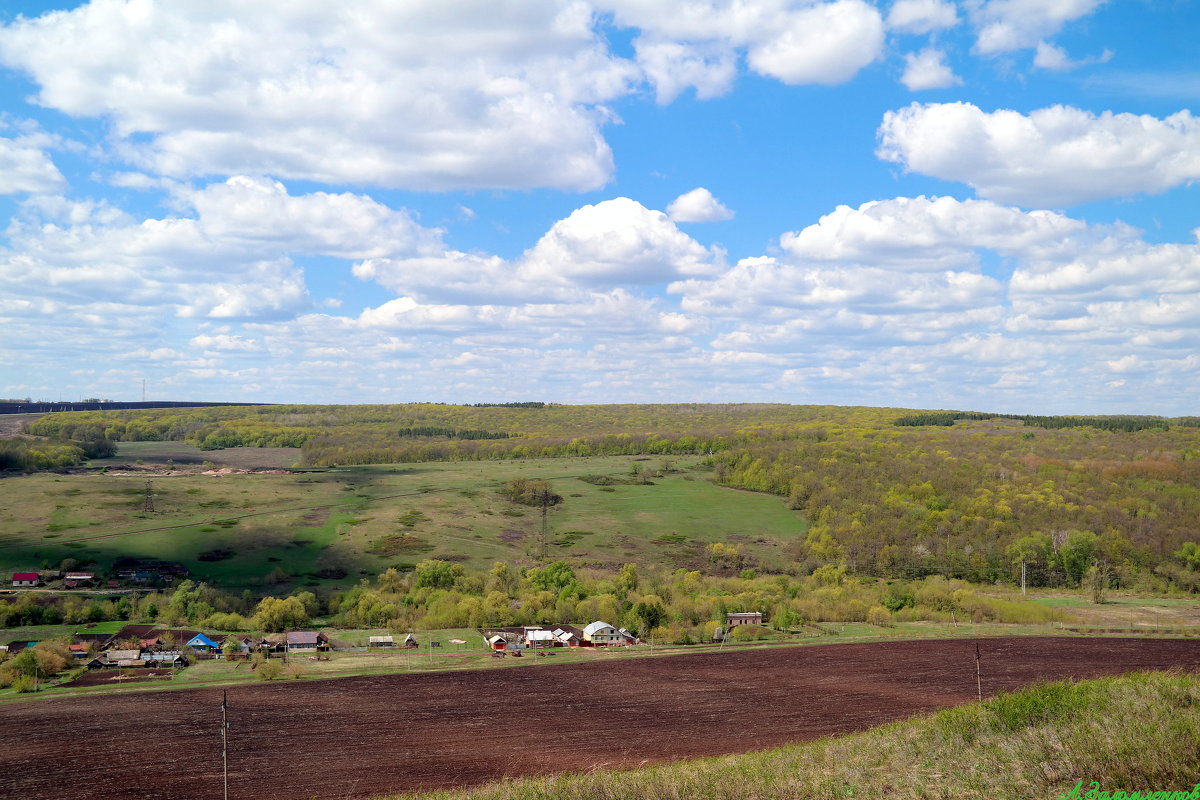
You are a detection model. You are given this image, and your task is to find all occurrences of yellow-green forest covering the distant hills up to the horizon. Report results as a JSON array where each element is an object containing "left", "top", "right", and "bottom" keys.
[{"left": 17, "top": 404, "right": 1200, "bottom": 591}]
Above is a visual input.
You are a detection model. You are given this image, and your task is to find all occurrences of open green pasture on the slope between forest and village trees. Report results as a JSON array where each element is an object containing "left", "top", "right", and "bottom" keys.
[{"left": 0, "top": 453, "right": 805, "bottom": 589}]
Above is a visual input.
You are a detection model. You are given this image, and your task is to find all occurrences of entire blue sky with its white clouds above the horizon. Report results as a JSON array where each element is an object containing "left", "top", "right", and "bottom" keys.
[{"left": 0, "top": 0, "right": 1200, "bottom": 415}]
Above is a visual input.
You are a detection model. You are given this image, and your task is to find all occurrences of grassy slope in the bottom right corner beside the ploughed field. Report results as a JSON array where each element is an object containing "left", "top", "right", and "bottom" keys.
[{"left": 376, "top": 673, "right": 1200, "bottom": 800}]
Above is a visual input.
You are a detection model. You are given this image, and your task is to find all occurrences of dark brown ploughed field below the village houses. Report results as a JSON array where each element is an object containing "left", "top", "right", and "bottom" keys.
[{"left": 0, "top": 638, "right": 1200, "bottom": 800}]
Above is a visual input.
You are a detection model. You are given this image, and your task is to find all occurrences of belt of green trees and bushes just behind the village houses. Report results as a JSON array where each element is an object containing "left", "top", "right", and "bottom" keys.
[{"left": 0, "top": 560, "right": 1089, "bottom": 644}]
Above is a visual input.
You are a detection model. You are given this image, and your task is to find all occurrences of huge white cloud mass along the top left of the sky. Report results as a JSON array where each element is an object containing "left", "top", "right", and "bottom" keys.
[{"left": 0, "top": 0, "right": 902, "bottom": 191}]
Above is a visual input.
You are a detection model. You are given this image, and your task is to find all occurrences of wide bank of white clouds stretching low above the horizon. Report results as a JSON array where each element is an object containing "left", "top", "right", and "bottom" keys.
[{"left": 0, "top": 178, "right": 1200, "bottom": 408}]
